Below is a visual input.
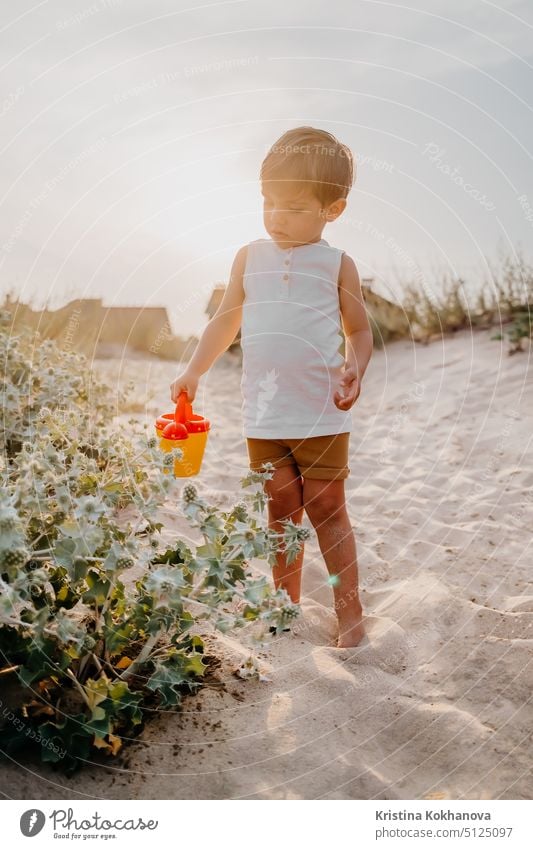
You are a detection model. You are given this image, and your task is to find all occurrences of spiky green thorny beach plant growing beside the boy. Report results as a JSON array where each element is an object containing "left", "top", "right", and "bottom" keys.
[{"left": 0, "top": 313, "right": 300, "bottom": 772}]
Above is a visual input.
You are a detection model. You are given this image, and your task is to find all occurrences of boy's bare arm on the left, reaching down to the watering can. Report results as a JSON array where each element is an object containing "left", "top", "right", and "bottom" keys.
[{"left": 170, "top": 246, "right": 246, "bottom": 401}]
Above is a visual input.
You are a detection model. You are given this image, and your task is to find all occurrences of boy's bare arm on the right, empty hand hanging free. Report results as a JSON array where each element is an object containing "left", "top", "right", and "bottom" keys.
[{"left": 334, "top": 254, "right": 374, "bottom": 410}]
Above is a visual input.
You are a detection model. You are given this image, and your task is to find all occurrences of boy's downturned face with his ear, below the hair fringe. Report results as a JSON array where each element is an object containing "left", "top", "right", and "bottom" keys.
[{"left": 262, "top": 180, "right": 346, "bottom": 248}]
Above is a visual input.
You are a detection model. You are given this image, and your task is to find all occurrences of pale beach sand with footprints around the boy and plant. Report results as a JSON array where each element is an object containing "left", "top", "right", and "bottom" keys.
[{"left": 3, "top": 324, "right": 533, "bottom": 799}]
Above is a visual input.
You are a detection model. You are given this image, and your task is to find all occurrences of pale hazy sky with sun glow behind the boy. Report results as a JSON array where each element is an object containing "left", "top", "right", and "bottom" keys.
[{"left": 0, "top": 0, "right": 533, "bottom": 337}]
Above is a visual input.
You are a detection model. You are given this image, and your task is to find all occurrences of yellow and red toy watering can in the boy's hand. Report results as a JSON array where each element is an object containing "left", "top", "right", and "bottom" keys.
[{"left": 155, "top": 392, "right": 211, "bottom": 478}]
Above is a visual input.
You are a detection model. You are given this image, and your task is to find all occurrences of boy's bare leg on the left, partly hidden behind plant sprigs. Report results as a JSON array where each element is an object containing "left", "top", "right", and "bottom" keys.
[{"left": 265, "top": 466, "right": 304, "bottom": 604}]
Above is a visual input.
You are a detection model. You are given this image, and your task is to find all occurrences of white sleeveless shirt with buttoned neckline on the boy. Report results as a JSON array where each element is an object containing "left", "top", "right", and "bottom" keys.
[{"left": 241, "top": 239, "right": 352, "bottom": 439}]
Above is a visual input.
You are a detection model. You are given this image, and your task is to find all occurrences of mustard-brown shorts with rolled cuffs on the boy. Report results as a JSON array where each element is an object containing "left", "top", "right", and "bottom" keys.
[{"left": 246, "top": 432, "right": 350, "bottom": 480}]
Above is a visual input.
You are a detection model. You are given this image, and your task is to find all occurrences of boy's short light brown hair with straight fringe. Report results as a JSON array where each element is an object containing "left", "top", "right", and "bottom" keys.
[{"left": 261, "top": 127, "right": 355, "bottom": 206}]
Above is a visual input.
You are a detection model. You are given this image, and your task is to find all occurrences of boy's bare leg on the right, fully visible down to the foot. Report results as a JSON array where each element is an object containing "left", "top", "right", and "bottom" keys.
[{"left": 304, "top": 478, "right": 365, "bottom": 648}]
